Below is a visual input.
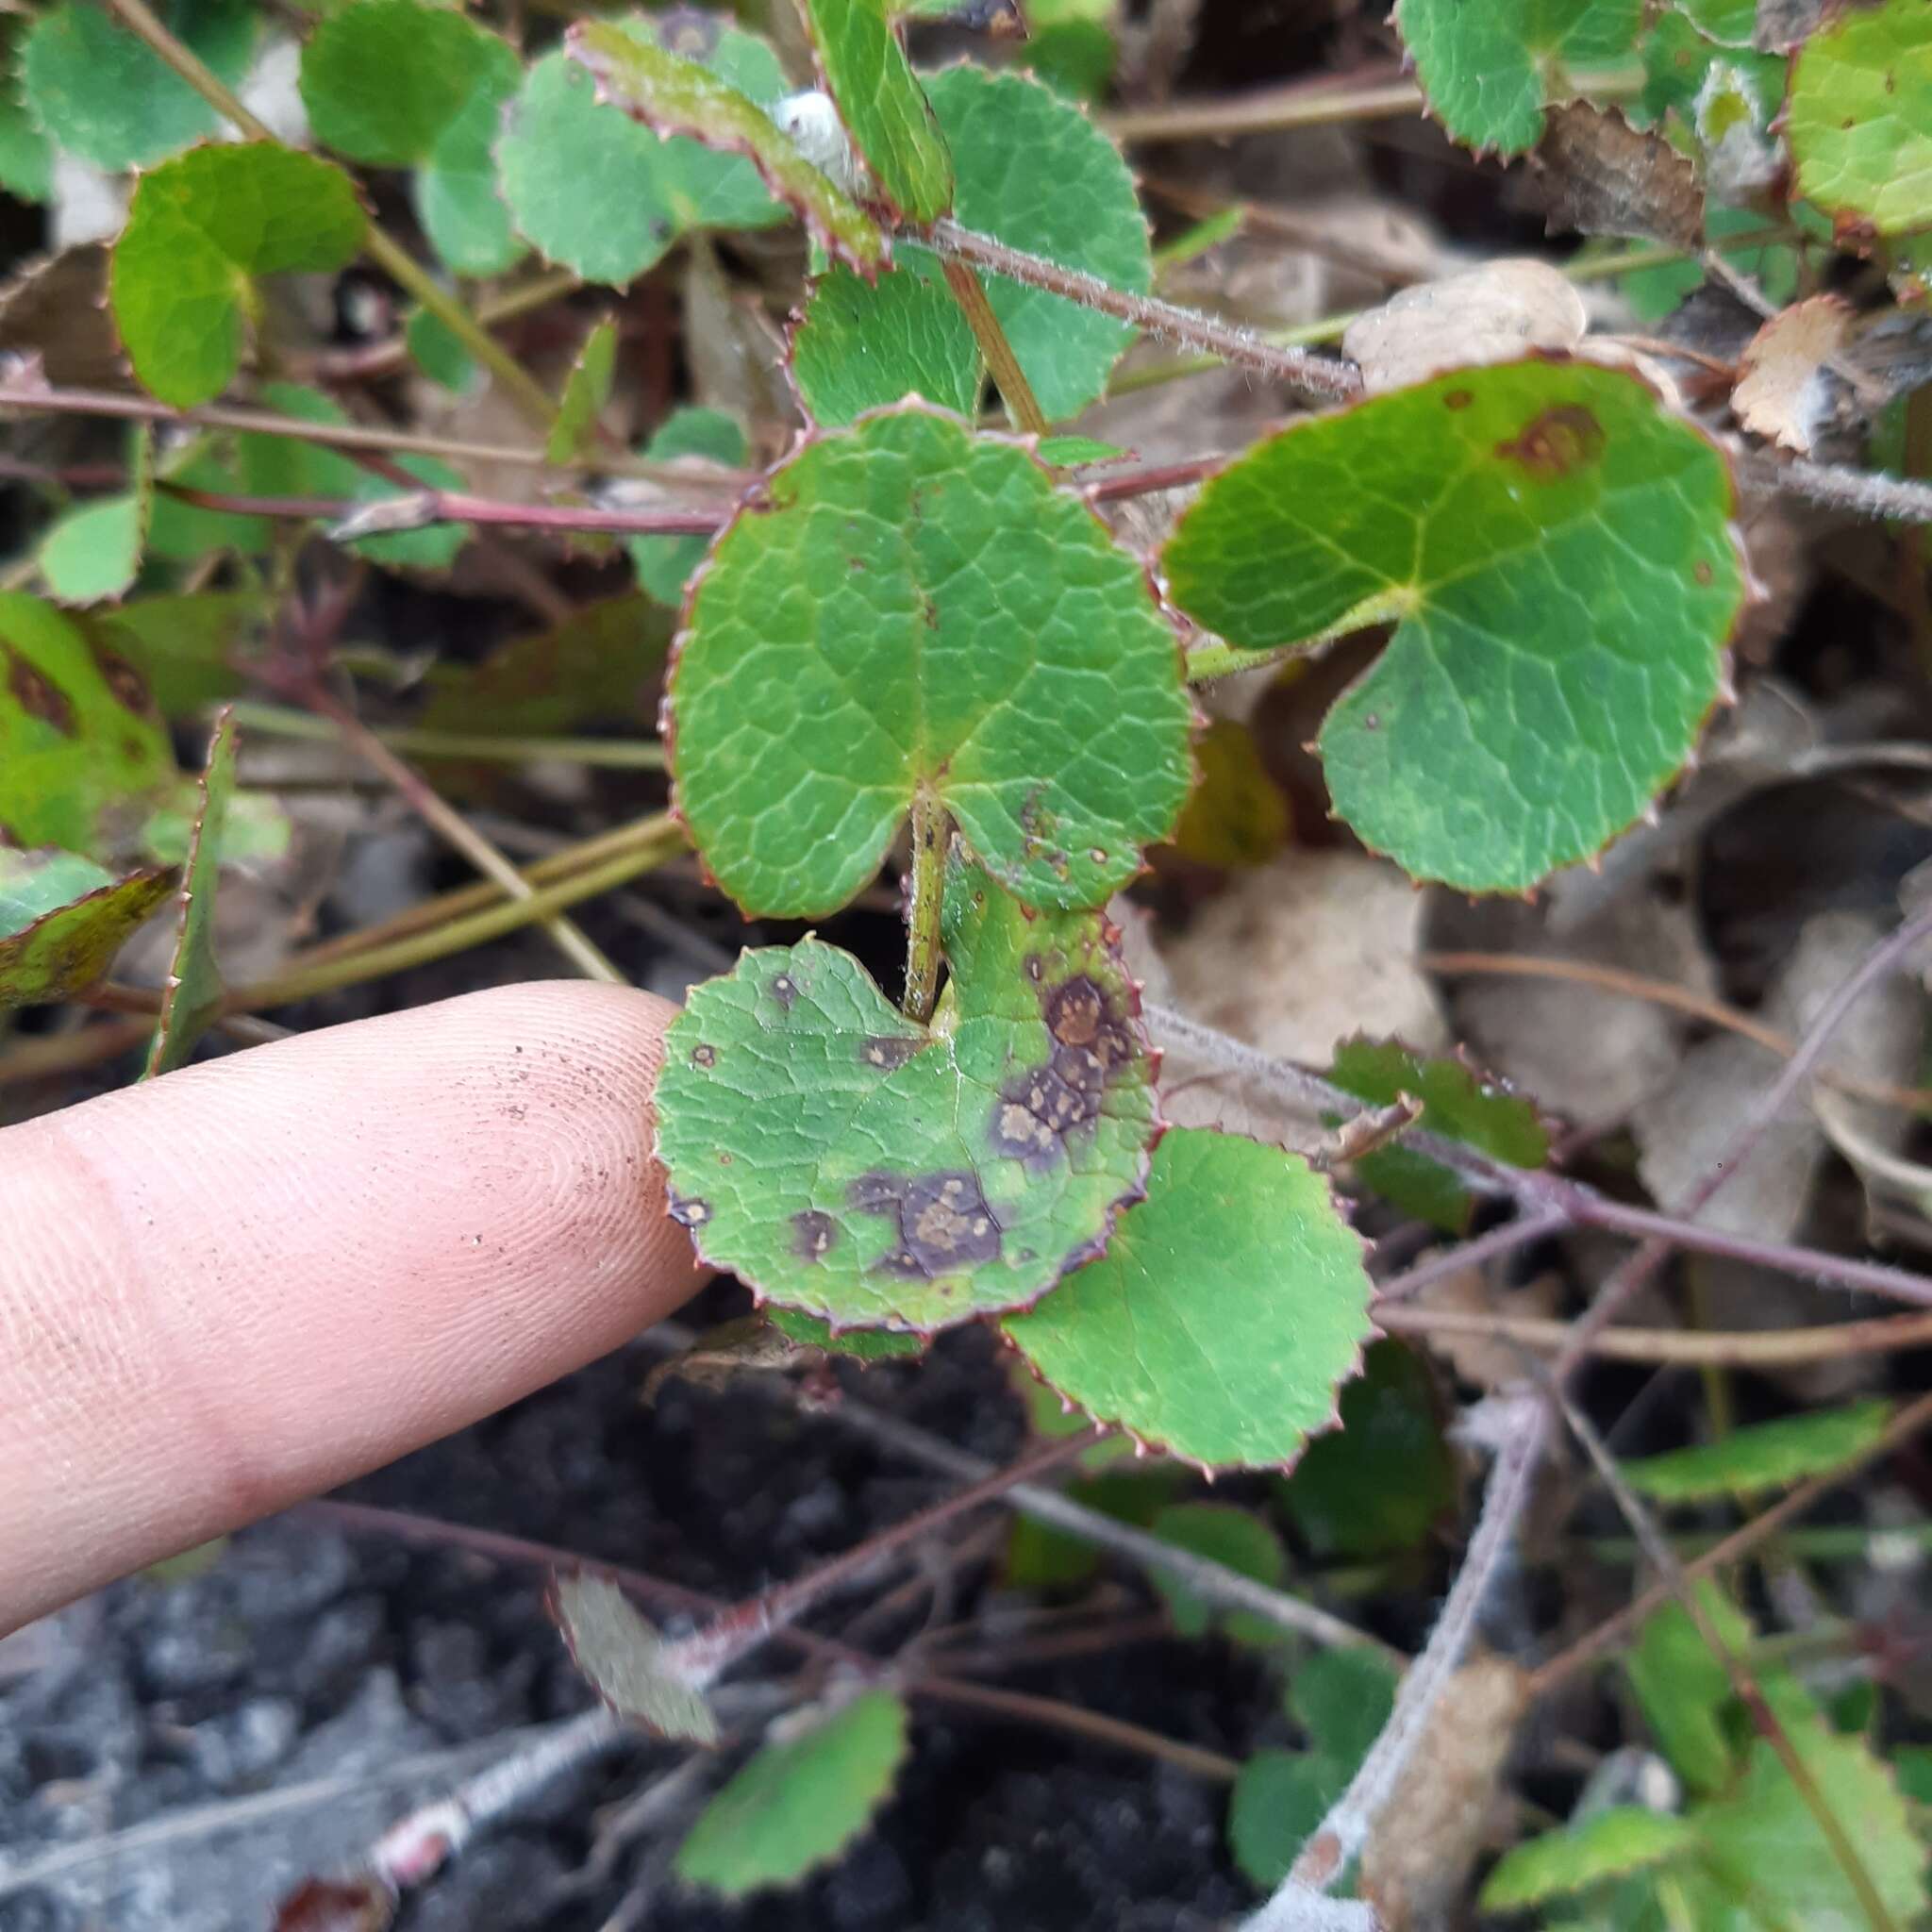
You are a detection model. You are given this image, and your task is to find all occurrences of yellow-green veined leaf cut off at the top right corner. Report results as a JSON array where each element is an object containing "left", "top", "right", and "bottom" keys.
[{"left": 1785, "top": 0, "right": 1932, "bottom": 238}]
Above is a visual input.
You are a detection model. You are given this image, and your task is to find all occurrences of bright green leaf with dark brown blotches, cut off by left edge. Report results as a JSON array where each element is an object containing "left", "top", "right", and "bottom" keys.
[{"left": 0, "top": 591, "right": 175, "bottom": 854}]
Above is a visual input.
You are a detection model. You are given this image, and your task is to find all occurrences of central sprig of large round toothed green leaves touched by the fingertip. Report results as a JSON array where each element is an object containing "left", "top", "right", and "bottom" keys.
[{"left": 566, "top": 11, "right": 1744, "bottom": 1471}]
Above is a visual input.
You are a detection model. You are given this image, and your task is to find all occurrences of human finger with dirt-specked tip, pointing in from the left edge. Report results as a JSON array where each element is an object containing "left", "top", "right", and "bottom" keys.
[{"left": 0, "top": 983, "right": 703, "bottom": 1633}]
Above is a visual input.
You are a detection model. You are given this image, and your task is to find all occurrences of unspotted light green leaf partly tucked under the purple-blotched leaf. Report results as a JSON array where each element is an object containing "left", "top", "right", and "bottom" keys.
[{"left": 1005, "top": 1128, "right": 1374, "bottom": 1468}]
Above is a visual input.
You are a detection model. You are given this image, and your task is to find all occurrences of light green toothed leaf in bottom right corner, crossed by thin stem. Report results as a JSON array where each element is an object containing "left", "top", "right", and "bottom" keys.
[{"left": 1692, "top": 1677, "right": 1928, "bottom": 1932}]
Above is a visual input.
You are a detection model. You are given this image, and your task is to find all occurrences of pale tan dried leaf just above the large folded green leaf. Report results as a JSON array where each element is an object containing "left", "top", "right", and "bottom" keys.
[{"left": 1341, "top": 258, "right": 1588, "bottom": 396}]
